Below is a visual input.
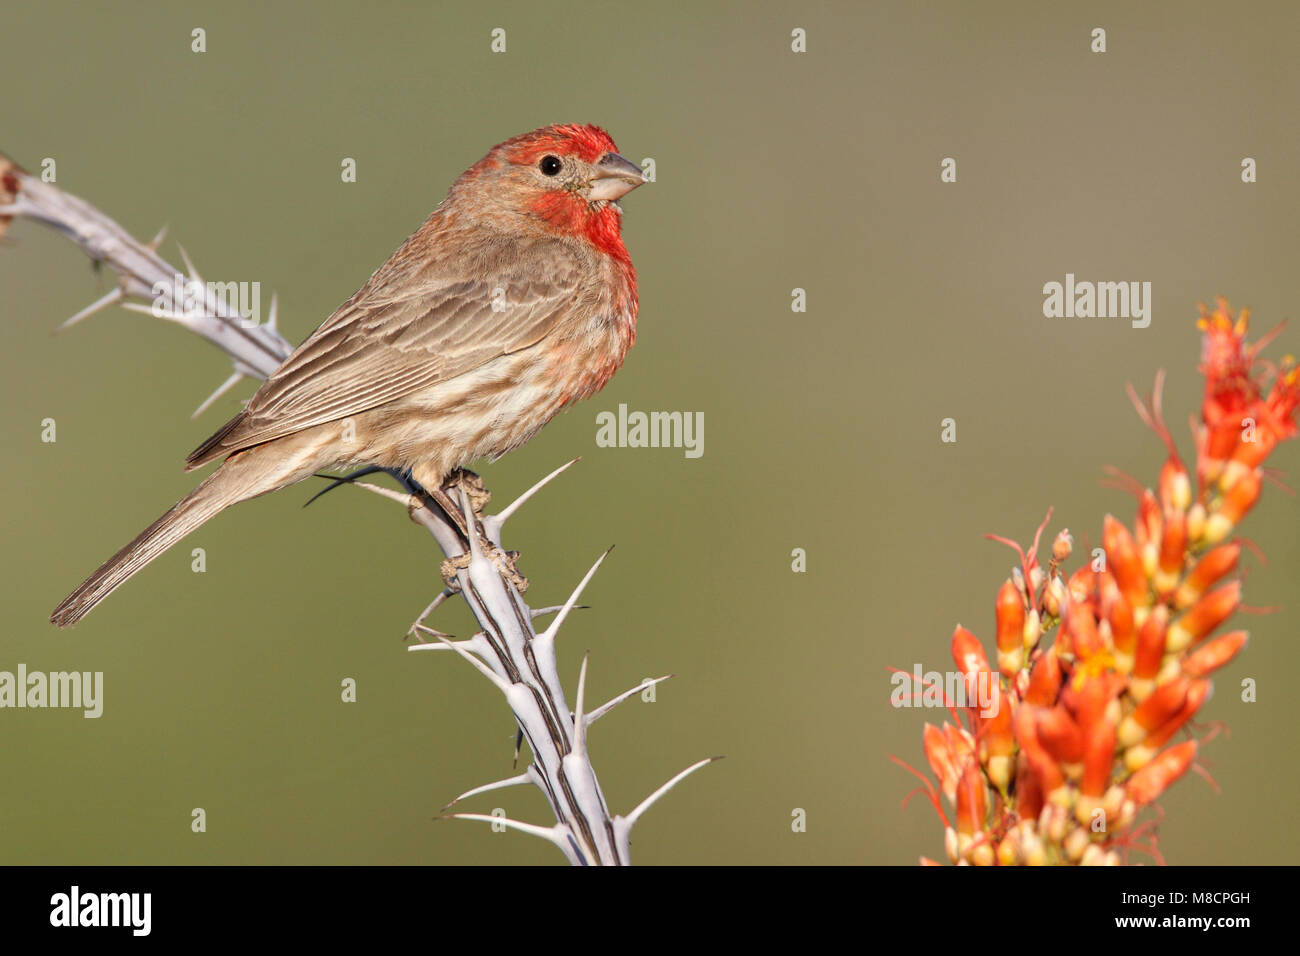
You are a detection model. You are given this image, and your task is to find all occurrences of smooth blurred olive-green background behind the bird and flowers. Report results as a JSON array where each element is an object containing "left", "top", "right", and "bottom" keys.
[{"left": 0, "top": 1, "right": 1300, "bottom": 864}]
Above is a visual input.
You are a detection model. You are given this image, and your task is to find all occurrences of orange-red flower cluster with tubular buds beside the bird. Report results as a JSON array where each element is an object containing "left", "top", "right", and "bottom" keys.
[{"left": 913, "top": 299, "right": 1300, "bottom": 865}]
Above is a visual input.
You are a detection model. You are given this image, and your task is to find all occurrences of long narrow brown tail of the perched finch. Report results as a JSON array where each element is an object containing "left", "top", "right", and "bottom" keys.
[{"left": 49, "top": 449, "right": 309, "bottom": 627}]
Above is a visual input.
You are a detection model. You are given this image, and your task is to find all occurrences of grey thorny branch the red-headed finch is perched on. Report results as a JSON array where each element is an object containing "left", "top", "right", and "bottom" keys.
[{"left": 0, "top": 155, "right": 716, "bottom": 865}]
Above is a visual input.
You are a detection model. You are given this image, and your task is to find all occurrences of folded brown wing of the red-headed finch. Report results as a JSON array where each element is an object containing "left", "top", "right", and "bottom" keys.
[{"left": 186, "top": 235, "right": 584, "bottom": 468}]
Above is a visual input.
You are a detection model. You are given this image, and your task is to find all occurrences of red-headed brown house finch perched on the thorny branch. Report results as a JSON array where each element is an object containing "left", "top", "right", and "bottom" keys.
[{"left": 49, "top": 125, "right": 645, "bottom": 627}]
